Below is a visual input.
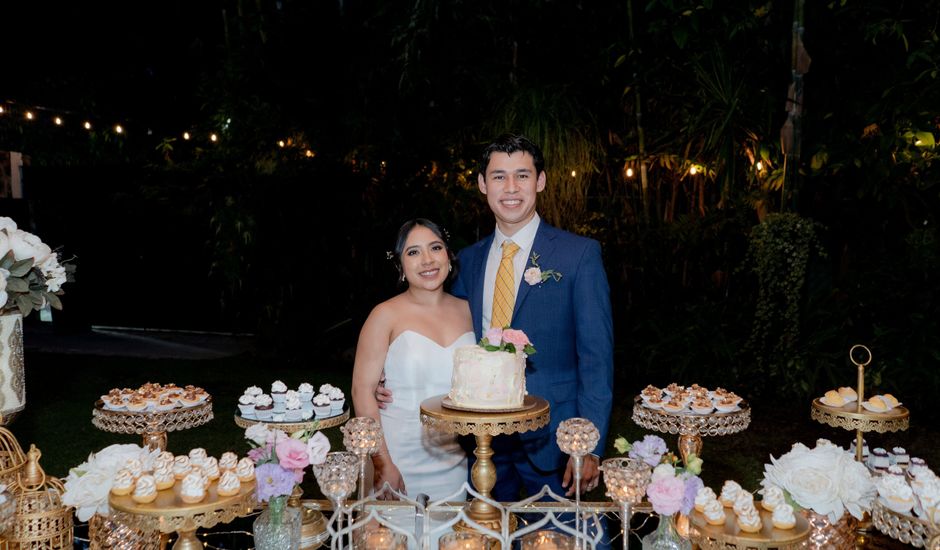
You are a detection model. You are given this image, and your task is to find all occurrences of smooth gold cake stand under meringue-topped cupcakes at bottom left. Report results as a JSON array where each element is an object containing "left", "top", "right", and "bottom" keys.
[{"left": 108, "top": 481, "right": 256, "bottom": 550}]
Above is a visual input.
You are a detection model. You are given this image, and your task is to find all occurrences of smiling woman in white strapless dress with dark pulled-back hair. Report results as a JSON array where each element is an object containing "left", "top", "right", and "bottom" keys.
[{"left": 352, "top": 218, "right": 474, "bottom": 501}]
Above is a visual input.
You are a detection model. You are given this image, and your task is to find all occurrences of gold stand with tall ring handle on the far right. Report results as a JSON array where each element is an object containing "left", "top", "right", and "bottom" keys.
[{"left": 810, "top": 344, "right": 910, "bottom": 462}]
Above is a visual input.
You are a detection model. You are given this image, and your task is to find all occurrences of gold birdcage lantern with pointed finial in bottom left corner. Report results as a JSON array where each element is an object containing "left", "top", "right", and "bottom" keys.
[{"left": 0, "top": 445, "right": 73, "bottom": 550}]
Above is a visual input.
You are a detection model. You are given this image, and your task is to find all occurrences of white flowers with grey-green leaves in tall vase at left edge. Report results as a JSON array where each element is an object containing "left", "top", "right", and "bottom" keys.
[{"left": 0, "top": 216, "right": 73, "bottom": 317}]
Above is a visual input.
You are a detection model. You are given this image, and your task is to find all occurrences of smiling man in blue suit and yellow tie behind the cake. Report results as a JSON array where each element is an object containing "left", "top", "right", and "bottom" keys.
[{"left": 452, "top": 134, "right": 613, "bottom": 502}]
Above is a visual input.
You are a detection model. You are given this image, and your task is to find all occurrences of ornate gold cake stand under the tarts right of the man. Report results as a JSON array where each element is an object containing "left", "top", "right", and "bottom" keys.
[{"left": 633, "top": 396, "right": 751, "bottom": 464}]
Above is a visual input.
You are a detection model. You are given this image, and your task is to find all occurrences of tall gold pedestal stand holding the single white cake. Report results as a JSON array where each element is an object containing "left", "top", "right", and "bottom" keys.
[{"left": 421, "top": 395, "right": 549, "bottom": 544}]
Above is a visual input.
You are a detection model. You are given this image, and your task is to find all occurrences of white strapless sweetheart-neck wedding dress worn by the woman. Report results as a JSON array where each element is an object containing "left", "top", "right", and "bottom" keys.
[{"left": 379, "top": 330, "right": 475, "bottom": 502}]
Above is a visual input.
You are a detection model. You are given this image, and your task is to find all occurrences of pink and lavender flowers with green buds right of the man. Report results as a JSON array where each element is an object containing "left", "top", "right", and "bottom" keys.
[{"left": 614, "top": 435, "right": 704, "bottom": 516}]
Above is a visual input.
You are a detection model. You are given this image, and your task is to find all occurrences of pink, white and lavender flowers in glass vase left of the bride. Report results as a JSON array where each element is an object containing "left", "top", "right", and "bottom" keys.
[{"left": 245, "top": 423, "right": 330, "bottom": 515}]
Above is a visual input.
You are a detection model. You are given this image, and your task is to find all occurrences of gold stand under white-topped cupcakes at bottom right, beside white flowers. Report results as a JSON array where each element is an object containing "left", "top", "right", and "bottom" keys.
[{"left": 689, "top": 503, "right": 811, "bottom": 550}]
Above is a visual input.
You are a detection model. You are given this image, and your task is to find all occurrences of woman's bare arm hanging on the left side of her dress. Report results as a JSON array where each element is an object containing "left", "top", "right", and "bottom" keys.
[{"left": 352, "top": 304, "right": 405, "bottom": 500}]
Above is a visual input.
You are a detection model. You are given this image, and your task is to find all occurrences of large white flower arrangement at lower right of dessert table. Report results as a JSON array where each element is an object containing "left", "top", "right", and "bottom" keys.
[{"left": 761, "top": 439, "right": 878, "bottom": 522}]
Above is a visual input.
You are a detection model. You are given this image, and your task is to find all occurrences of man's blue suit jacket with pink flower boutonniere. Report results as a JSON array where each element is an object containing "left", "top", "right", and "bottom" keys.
[{"left": 452, "top": 221, "right": 613, "bottom": 470}]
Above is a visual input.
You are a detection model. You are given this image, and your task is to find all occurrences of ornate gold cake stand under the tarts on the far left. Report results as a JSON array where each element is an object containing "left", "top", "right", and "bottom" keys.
[{"left": 91, "top": 396, "right": 213, "bottom": 451}]
